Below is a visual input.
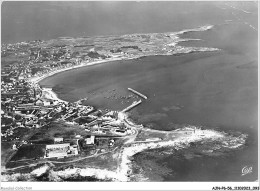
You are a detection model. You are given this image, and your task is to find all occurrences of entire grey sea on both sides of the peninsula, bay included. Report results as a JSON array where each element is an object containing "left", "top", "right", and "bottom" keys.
[{"left": 2, "top": 2, "right": 258, "bottom": 182}]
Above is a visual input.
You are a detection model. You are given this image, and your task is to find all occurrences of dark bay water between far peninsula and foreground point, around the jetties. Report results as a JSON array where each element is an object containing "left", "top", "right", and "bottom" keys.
[{"left": 40, "top": 20, "right": 258, "bottom": 181}]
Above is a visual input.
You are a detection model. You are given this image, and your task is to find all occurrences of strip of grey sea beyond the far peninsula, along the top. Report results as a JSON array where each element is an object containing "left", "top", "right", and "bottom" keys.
[{"left": 1, "top": 1, "right": 257, "bottom": 43}]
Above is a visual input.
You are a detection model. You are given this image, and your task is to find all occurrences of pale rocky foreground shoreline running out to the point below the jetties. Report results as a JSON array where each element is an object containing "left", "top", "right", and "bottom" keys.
[{"left": 2, "top": 126, "right": 247, "bottom": 182}]
